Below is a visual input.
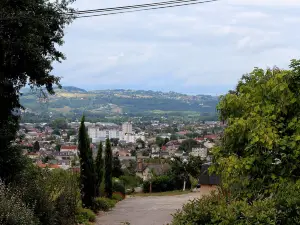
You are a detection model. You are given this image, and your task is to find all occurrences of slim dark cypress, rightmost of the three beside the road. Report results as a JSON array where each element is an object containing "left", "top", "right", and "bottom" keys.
[{"left": 104, "top": 139, "right": 112, "bottom": 198}]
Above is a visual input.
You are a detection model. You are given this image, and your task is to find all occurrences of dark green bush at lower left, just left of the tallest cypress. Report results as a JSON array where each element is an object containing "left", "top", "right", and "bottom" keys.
[{"left": 5, "top": 163, "right": 80, "bottom": 225}]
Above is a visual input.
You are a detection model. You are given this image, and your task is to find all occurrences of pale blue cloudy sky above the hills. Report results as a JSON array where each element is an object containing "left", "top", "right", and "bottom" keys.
[{"left": 54, "top": 0, "right": 300, "bottom": 95}]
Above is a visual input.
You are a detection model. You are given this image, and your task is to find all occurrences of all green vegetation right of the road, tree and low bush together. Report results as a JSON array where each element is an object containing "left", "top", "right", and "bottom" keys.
[{"left": 172, "top": 60, "right": 300, "bottom": 225}]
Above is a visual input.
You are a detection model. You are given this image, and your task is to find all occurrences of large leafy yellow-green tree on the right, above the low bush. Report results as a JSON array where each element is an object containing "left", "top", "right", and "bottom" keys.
[{"left": 213, "top": 60, "right": 300, "bottom": 199}]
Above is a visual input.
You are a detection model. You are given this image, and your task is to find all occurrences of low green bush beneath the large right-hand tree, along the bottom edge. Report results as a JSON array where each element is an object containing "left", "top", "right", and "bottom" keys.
[{"left": 172, "top": 185, "right": 300, "bottom": 225}]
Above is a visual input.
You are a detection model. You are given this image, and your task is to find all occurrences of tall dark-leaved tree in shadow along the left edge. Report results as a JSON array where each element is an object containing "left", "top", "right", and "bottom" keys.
[{"left": 0, "top": 0, "right": 73, "bottom": 181}]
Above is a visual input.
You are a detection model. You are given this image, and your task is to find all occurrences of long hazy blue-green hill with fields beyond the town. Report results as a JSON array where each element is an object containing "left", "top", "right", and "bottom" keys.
[{"left": 21, "top": 86, "right": 219, "bottom": 120}]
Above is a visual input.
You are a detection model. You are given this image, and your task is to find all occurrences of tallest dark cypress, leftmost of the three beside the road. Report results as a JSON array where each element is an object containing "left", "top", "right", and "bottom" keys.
[{"left": 78, "top": 116, "right": 96, "bottom": 208}]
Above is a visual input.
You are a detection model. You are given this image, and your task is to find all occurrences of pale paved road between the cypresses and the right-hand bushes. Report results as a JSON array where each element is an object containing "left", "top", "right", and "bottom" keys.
[{"left": 97, "top": 187, "right": 211, "bottom": 225}]
